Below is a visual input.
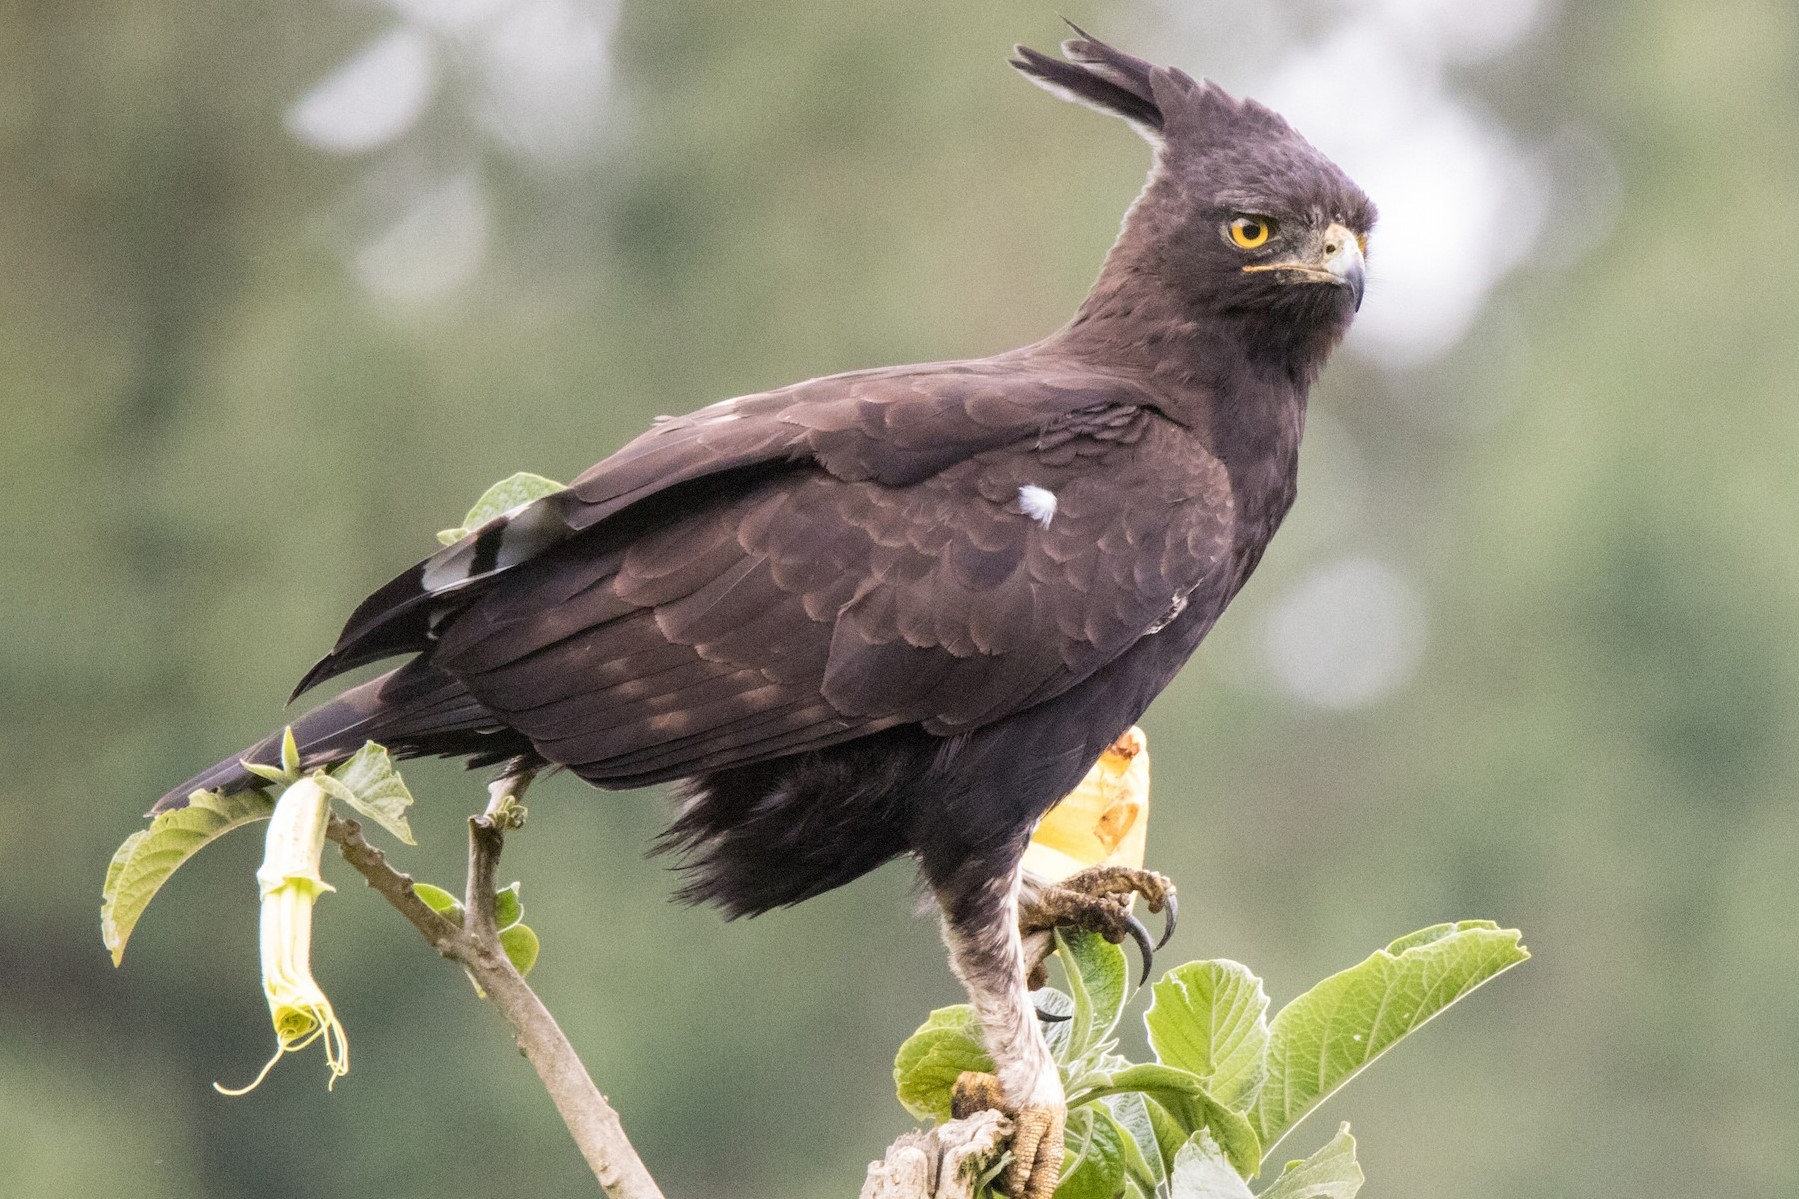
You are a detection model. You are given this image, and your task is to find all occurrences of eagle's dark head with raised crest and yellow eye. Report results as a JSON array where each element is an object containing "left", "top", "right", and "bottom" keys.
[{"left": 1013, "top": 29, "right": 1374, "bottom": 360}]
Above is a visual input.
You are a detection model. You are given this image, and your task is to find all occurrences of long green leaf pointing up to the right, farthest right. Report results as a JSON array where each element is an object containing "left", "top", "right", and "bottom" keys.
[{"left": 1250, "top": 920, "right": 1531, "bottom": 1149}]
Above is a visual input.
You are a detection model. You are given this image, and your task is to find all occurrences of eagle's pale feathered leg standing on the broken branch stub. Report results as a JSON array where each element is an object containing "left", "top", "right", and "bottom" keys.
[{"left": 935, "top": 866, "right": 1069, "bottom": 1199}]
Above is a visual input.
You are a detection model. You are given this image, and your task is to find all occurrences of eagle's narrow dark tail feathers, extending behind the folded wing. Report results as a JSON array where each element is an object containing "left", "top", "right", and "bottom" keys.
[{"left": 149, "top": 659, "right": 533, "bottom": 816}]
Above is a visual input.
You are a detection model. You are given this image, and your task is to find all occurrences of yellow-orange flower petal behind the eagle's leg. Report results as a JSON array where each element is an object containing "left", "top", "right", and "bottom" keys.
[{"left": 1024, "top": 727, "right": 1150, "bottom": 882}]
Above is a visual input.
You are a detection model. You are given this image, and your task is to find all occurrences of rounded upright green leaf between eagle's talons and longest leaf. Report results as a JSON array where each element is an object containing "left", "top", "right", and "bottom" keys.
[{"left": 1142, "top": 960, "right": 1268, "bottom": 1111}]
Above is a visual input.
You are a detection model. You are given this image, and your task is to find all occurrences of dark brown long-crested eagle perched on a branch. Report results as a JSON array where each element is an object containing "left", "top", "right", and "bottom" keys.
[{"left": 157, "top": 31, "right": 1374, "bottom": 1199}]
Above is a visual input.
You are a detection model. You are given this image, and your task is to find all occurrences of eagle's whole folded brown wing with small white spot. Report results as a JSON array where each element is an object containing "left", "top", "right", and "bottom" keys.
[{"left": 308, "top": 360, "right": 1232, "bottom": 787}]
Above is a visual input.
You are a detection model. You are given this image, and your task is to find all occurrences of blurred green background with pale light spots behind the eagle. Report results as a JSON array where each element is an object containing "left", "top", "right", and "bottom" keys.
[{"left": 0, "top": 0, "right": 1799, "bottom": 1199}]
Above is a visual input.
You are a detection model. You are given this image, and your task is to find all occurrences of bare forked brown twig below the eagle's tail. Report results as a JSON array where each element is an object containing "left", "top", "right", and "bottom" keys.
[{"left": 326, "top": 789, "right": 662, "bottom": 1199}]
